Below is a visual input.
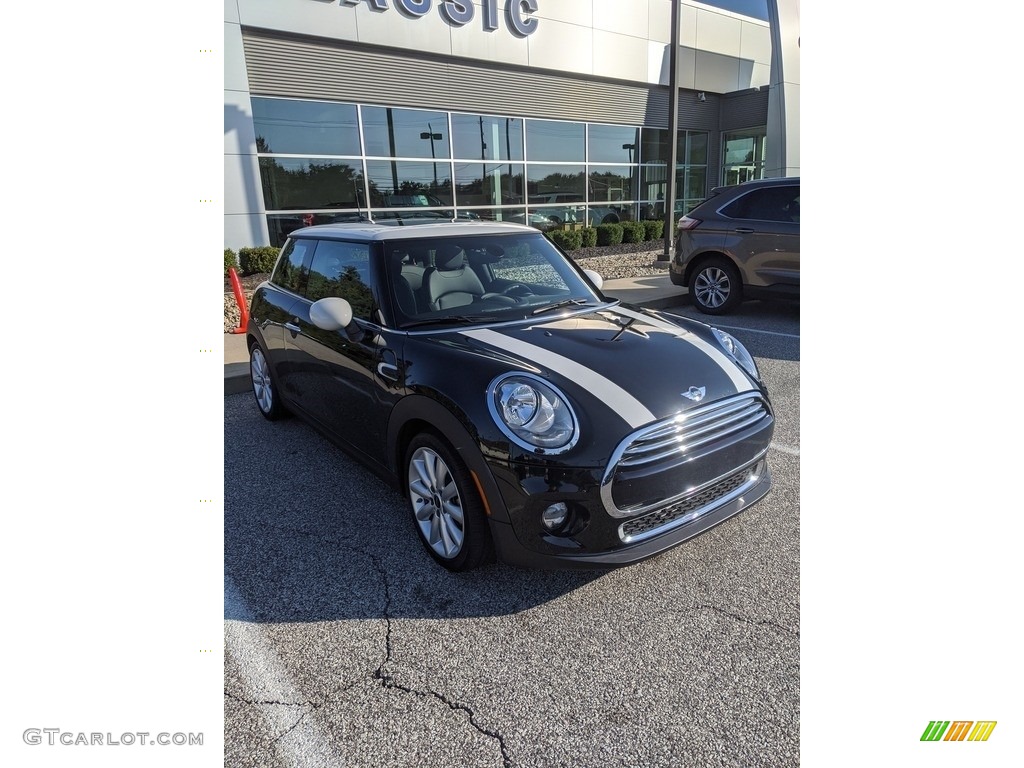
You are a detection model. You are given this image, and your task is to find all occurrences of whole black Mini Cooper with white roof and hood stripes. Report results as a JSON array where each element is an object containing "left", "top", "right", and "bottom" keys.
[{"left": 247, "top": 222, "right": 774, "bottom": 570}]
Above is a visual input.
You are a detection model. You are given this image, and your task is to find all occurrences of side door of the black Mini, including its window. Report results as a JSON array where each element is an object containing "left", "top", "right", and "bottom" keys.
[{"left": 285, "top": 240, "right": 397, "bottom": 462}]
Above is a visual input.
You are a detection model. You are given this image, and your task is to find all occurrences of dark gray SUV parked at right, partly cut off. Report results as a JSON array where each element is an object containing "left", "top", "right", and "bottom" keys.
[{"left": 669, "top": 177, "right": 800, "bottom": 314}]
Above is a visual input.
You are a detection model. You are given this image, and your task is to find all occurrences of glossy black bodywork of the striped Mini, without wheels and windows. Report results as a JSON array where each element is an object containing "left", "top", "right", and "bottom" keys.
[{"left": 248, "top": 224, "right": 774, "bottom": 567}]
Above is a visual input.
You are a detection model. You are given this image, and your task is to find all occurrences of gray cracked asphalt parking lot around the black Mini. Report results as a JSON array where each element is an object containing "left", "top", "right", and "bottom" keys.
[{"left": 224, "top": 302, "right": 800, "bottom": 768}]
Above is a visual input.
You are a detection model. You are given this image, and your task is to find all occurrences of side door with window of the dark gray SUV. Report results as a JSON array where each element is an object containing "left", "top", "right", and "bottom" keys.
[{"left": 721, "top": 184, "right": 800, "bottom": 291}]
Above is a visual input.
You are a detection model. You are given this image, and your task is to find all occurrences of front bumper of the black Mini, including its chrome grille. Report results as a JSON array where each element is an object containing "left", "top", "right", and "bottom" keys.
[{"left": 489, "top": 392, "right": 774, "bottom": 568}]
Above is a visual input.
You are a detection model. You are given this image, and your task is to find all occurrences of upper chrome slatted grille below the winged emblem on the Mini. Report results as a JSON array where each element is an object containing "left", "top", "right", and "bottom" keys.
[{"left": 615, "top": 393, "right": 769, "bottom": 468}]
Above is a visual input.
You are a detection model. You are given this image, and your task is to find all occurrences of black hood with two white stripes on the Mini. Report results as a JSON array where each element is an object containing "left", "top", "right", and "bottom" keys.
[{"left": 436, "top": 305, "right": 760, "bottom": 430}]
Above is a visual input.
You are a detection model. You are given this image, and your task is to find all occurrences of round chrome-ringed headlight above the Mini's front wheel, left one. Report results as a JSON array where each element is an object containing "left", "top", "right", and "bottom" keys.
[{"left": 487, "top": 374, "right": 580, "bottom": 454}]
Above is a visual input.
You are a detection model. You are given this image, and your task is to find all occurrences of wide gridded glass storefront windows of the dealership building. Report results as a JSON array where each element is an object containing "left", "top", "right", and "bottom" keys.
[{"left": 252, "top": 97, "right": 708, "bottom": 246}]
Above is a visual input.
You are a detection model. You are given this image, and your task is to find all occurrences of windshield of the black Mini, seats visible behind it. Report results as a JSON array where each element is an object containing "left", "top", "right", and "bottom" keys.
[{"left": 384, "top": 232, "right": 604, "bottom": 328}]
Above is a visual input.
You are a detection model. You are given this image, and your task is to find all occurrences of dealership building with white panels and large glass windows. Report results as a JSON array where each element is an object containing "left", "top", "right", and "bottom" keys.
[{"left": 224, "top": 0, "right": 800, "bottom": 249}]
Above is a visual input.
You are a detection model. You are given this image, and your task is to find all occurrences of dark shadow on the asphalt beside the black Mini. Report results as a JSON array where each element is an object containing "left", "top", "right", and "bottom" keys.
[{"left": 224, "top": 395, "right": 607, "bottom": 623}]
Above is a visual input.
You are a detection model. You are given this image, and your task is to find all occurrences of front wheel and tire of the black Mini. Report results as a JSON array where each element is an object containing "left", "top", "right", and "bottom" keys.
[{"left": 404, "top": 432, "right": 495, "bottom": 571}]
